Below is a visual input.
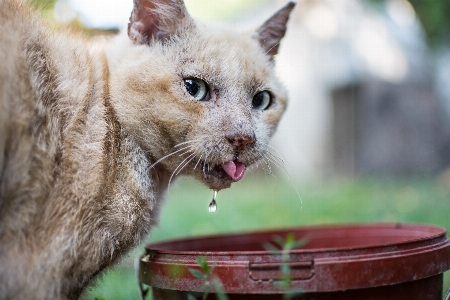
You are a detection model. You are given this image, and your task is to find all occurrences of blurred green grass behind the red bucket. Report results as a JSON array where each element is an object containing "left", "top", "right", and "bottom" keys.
[{"left": 84, "top": 174, "right": 450, "bottom": 300}]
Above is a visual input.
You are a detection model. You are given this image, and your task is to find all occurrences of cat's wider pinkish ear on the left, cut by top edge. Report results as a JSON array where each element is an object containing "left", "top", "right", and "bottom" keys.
[{"left": 128, "top": 0, "right": 193, "bottom": 44}]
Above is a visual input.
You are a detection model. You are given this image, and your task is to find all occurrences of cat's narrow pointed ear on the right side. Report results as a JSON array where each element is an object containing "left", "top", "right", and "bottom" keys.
[{"left": 256, "top": 2, "right": 295, "bottom": 56}]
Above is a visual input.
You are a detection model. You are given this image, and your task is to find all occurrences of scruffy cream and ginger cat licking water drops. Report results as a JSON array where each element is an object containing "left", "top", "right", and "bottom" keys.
[{"left": 0, "top": 0, "right": 295, "bottom": 299}]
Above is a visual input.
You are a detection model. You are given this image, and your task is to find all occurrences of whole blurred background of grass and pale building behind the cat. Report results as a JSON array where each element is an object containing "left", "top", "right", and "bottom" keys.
[{"left": 27, "top": 0, "right": 450, "bottom": 300}]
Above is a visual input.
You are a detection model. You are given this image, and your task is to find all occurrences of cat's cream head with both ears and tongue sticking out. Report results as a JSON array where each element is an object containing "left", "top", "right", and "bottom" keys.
[{"left": 109, "top": 0, "right": 294, "bottom": 190}]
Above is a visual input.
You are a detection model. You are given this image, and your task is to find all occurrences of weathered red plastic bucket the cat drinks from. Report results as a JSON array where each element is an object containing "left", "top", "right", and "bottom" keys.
[{"left": 139, "top": 224, "right": 450, "bottom": 300}]
